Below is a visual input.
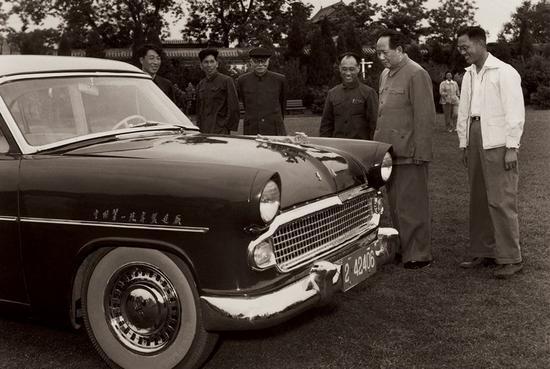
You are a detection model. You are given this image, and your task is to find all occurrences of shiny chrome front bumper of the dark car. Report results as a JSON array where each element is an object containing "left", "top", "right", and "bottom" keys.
[{"left": 200, "top": 228, "right": 399, "bottom": 331}]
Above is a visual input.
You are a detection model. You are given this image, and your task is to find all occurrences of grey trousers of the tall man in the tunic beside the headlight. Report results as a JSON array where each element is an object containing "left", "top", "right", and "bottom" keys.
[{"left": 386, "top": 163, "right": 432, "bottom": 263}]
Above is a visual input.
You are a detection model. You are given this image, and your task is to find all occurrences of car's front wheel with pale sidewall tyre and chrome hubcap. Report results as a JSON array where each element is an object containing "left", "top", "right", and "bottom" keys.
[{"left": 82, "top": 247, "right": 218, "bottom": 369}]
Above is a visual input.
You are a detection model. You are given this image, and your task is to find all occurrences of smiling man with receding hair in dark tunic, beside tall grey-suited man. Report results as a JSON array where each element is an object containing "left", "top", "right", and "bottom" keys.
[{"left": 320, "top": 53, "right": 378, "bottom": 140}]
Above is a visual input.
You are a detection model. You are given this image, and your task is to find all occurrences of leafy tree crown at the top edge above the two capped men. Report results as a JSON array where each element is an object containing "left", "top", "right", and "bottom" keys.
[{"left": 182, "top": 0, "right": 311, "bottom": 47}]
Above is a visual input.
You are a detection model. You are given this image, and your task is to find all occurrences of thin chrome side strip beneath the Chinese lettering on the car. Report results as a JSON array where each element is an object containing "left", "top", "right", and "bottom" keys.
[{"left": 21, "top": 217, "right": 210, "bottom": 233}]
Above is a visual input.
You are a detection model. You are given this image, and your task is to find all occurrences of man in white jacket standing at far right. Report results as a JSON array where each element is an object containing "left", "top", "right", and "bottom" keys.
[{"left": 457, "top": 26, "right": 525, "bottom": 278}]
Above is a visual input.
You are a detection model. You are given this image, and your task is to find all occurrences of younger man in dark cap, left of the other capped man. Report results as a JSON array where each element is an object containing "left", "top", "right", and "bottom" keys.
[{"left": 197, "top": 49, "right": 240, "bottom": 134}]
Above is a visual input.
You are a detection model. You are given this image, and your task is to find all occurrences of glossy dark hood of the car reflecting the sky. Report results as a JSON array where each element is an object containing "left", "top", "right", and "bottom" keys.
[{"left": 65, "top": 133, "right": 384, "bottom": 208}]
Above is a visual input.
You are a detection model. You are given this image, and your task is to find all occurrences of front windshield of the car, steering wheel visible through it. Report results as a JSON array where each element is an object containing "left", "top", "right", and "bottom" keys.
[{"left": 0, "top": 76, "right": 194, "bottom": 146}]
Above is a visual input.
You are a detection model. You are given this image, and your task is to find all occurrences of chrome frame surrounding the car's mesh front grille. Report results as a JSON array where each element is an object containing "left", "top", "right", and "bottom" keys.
[{"left": 248, "top": 184, "right": 380, "bottom": 271}]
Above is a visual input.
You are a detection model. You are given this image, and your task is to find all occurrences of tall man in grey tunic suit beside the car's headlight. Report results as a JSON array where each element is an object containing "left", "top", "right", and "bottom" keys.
[{"left": 374, "top": 30, "right": 436, "bottom": 269}]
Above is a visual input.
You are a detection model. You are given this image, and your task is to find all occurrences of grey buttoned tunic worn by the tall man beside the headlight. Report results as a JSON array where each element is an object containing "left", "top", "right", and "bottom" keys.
[{"left": 374, "top": 55, "right": 435, "bottom": 165}]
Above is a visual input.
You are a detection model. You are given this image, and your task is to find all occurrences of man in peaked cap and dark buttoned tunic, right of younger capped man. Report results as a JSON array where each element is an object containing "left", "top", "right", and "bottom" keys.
[{"left": 237, "top": 47, "right": 286, "bottom": 136}]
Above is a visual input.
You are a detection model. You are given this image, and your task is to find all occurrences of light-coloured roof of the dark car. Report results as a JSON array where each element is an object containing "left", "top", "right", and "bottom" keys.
[{"left": 0, "top": 55, "right": 144, "bottom": 78}]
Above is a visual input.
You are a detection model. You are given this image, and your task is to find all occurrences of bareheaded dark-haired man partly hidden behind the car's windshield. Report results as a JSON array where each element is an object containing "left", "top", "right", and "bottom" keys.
[{"left": 137, "top": 44, "right": 184, "bottom": 104}]
